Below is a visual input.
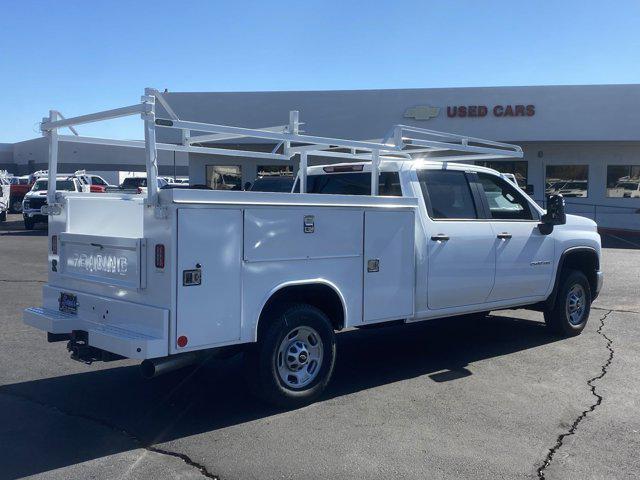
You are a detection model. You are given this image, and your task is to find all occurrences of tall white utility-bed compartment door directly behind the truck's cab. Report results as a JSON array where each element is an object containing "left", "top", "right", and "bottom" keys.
[{"left": 364, "top": 211, "right": 415, "bottom": 322}]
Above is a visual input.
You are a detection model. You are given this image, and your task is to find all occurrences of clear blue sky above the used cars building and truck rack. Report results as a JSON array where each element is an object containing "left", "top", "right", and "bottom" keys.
[{"left": 0, "top": 0, "right": 640, "bottom": 142}]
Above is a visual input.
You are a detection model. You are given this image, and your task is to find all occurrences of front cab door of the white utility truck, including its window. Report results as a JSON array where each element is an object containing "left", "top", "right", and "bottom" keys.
[{"left": 474, "top": 172, "right": 555, "bottom": 301}]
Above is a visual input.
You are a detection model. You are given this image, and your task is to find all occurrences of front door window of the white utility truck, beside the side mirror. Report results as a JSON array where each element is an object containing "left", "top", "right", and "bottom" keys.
[{"left": 478, "top": 172, "right": 533, "bottom": 220}]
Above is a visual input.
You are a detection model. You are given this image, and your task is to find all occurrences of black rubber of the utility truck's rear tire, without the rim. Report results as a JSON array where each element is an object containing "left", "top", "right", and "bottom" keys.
[{"left": 244, "top": 304, "right": 336, "bottom": 409}]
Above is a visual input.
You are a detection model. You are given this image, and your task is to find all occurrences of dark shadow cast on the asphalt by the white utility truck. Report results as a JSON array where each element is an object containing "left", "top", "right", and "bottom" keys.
[{"left": 0, "top": 316, "right": 556, "bottom": 478}]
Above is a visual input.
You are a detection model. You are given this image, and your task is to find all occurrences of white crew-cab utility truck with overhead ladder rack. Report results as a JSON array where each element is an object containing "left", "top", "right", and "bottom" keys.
[{"left": 24, "top": 89, "right": 602, "bottom": 407}]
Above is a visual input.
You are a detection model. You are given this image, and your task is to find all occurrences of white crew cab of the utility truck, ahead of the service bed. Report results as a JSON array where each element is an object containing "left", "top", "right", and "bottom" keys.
[{"left": 294, "top": 160, "right": 602, "bottom": 320}]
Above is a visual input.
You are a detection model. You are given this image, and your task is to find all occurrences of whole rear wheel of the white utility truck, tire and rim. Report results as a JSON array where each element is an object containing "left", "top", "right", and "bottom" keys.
[{"left": 244, "top": 304, "right": 336, "bottom": 408}]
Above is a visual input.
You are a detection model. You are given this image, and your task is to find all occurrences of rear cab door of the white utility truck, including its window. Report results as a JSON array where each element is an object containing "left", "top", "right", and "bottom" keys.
[{"left": 417, "top": 169, "right": 495, "bottom": 309}]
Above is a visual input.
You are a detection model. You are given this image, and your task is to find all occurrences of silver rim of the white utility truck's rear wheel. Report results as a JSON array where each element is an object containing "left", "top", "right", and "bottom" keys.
[{"left": 276, "top": 326, "right": 323, "bottom": 389}]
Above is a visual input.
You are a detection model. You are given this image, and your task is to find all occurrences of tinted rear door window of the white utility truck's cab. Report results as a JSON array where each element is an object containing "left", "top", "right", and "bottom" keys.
[{"left": 418, "top": 170, "right": 478, "bottom": 220}]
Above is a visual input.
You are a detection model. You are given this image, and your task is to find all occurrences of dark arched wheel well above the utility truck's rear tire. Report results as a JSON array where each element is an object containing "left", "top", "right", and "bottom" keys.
[{"left": 258, "top": 283, "right": 345, "bottom": 338}]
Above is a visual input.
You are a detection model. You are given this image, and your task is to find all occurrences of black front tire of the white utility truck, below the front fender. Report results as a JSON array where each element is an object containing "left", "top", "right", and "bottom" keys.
[{"left": 544, "top": 270, "right": 592, "bottom": 337}]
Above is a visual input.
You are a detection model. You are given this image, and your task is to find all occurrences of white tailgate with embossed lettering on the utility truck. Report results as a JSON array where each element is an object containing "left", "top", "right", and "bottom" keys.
[{"left": 57, "top": 233, "right": 146, "bottom": 289}]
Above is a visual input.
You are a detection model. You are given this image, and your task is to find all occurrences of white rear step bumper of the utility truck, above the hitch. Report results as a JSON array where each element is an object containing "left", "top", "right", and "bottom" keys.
[{"left": 23, "top": 285, "right": 169, "bottom": 360}]
